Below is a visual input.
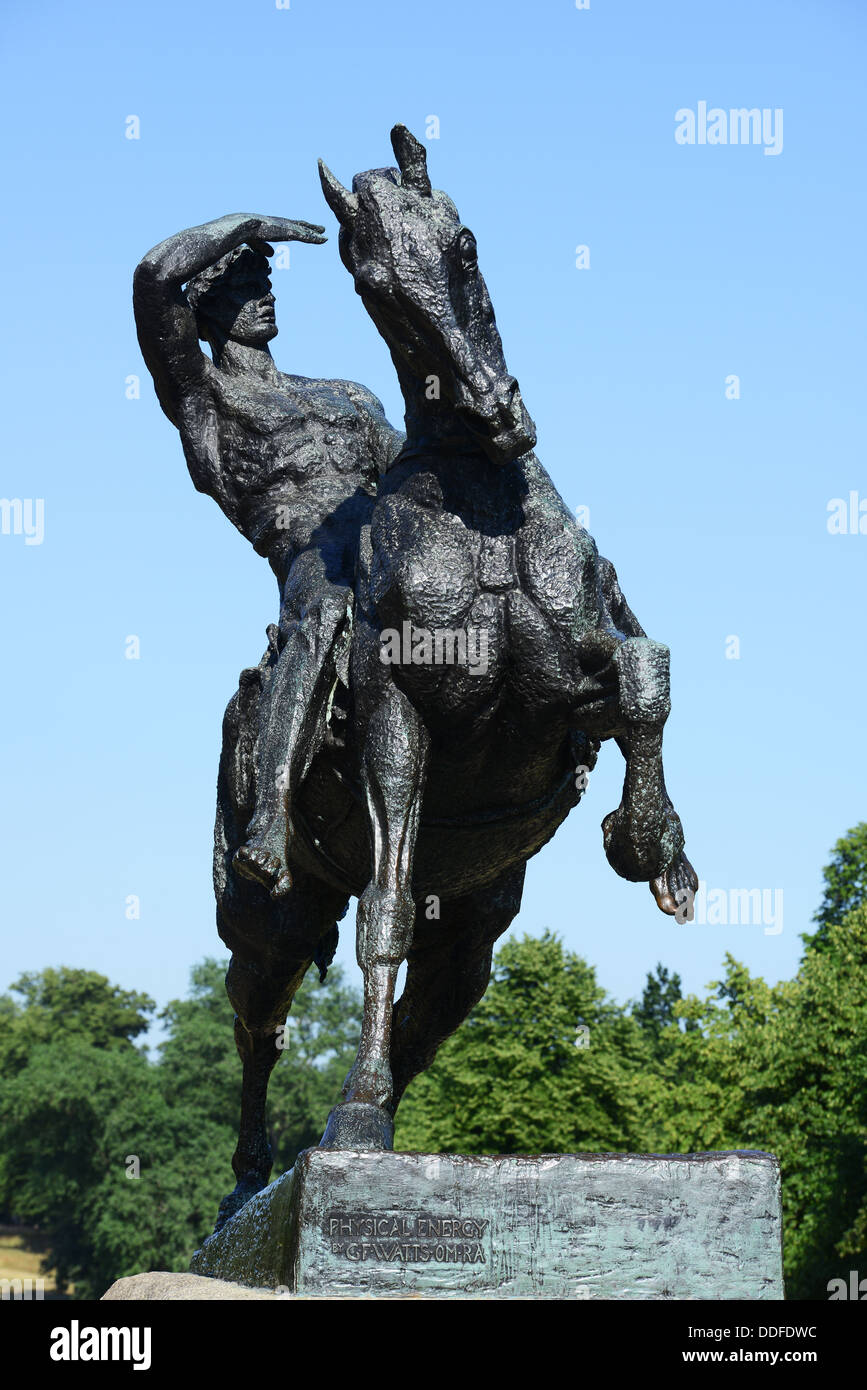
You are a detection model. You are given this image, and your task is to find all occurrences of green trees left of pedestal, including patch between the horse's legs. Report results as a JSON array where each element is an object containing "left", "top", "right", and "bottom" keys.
[{"left": 0, "top": 959, "right": 358, "bottom": 1298}]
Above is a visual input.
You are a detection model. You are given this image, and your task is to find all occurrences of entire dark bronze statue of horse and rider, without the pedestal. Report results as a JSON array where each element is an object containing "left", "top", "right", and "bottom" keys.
[{"left": 135, "top": 125, "right": 697, "bottom": 1226}]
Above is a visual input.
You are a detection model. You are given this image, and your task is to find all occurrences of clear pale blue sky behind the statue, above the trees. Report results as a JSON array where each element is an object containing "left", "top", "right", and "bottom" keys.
[{"left": 0, "top": 0, "right": 867, "bottom": 1034}]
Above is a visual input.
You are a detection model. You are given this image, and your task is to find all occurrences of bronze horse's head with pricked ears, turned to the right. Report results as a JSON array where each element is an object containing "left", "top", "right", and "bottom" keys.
[{"left": 320, "top": 125, "right": 536, "bottom": 463}]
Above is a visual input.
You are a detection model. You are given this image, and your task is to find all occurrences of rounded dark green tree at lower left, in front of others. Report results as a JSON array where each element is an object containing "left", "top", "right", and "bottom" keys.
[{"left": 0, "top": 1037, "right": 232, "bottom": 1298}]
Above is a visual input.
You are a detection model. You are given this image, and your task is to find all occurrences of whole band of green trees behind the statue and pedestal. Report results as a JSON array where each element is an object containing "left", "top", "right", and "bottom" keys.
[{"left": 0, "top": 824, "right": 867, "bottom": 1298}]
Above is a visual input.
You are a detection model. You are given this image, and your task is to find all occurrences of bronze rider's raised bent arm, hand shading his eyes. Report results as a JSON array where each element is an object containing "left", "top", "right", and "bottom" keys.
[{"left": 132, "top": 213, "right": 325, "bottom": 425}]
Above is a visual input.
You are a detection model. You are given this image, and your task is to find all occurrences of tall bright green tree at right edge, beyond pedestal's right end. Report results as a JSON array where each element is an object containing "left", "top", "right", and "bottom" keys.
[{"left": 653, "top": 905, "right": 867, "bottom": 1298}]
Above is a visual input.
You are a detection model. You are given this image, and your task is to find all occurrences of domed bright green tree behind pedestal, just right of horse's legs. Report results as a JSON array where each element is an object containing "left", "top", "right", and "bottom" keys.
[{"left": 396, "top": 931, "right": 653, "bottom": 1154}]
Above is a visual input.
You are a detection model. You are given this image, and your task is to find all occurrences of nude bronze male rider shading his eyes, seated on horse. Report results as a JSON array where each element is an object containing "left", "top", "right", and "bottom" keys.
[{"left": 133, "top": 213, "right": 403, "bottom": 897}]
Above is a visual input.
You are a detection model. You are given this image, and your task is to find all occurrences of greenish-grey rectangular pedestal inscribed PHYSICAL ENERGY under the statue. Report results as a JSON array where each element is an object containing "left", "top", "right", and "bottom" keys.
[{"left": 190, "top": 1148, "right": 784, "bottom": 1300}]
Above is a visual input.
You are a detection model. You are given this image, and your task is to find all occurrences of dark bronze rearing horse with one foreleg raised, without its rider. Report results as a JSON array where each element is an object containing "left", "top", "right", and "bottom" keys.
[{"left": 207, "top": 125, "right": 697, "bottom": 1226}]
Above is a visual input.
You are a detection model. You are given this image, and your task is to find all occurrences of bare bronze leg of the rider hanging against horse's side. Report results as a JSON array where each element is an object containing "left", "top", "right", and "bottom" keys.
[{"left": 233, "top": 550, "right": 353, "bottom": 898}]
